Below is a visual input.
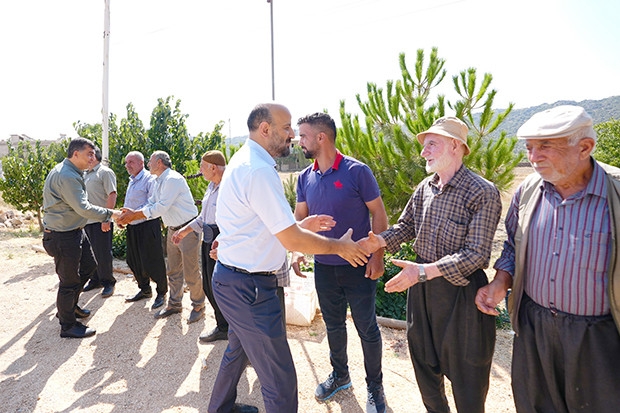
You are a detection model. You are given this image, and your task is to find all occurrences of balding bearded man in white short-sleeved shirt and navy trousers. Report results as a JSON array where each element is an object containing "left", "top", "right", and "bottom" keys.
[{"left": 208, "top": 103, "right": 368, "bottom": 413}]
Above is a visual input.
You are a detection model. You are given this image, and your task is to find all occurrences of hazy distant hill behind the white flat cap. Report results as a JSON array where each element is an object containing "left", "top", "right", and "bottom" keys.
[{"left": 484, "top": 96, "right": 620, "bottom": 136}]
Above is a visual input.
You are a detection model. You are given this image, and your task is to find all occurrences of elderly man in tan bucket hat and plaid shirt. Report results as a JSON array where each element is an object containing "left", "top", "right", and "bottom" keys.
[{"left": 360, "top": 117, "right": 502, "bottom": 413}]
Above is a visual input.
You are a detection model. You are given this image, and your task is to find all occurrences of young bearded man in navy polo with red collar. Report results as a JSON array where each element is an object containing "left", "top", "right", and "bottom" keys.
[{"left": 295, "top": 113, "right": 388, "bottom": 413}]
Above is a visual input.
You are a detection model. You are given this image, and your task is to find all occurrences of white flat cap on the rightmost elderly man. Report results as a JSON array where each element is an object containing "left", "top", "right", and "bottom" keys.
[{"left": 517, "top": 105, "right": 596, "bottom": 139}]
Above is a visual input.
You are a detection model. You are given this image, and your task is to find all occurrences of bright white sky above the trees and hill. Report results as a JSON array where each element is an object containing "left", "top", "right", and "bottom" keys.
[{"left": 0, "top": 0, "right": 620, "bottom": 140}]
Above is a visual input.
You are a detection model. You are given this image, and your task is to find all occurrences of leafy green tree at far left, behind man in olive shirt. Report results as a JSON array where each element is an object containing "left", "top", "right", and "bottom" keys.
[{"left": 0, "top": 141, "right": 56, "bottom": 231}]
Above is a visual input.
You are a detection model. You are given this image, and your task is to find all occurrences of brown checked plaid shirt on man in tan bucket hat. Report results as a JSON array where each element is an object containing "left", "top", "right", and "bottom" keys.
[{"left": 381, "top": 166, "right": 502, "bottom": 286}]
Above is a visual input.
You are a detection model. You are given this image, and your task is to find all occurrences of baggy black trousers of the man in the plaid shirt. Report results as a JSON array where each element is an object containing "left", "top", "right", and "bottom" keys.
[{"left": 407, "top": 270, "right": 495, "bottom": 413}]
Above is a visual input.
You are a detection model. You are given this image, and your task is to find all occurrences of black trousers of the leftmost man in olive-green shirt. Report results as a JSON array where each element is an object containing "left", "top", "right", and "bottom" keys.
[{"left": 43, "top": 228, "right": 97, "bottom": 330}]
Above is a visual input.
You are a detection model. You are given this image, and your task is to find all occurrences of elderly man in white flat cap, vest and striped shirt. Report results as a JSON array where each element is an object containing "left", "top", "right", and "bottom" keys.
[{"left": 476, "top": 106, "right": 620, "bottom": 413}]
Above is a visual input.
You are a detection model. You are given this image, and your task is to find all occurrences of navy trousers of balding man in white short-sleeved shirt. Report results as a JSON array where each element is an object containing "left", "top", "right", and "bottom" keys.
[{"left": 208, "top": 262, "right": 298, "bottom": 413}]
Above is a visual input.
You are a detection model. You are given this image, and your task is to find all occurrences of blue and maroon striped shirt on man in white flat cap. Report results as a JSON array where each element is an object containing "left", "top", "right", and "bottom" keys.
[{"left": 495, "top": 163, "right": 611, "bottom": 316}]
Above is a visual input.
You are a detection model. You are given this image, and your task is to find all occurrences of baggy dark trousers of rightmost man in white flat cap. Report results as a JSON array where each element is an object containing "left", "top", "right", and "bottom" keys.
[{"left": 512, "top": 295, "right": 620, "bottom": 413}]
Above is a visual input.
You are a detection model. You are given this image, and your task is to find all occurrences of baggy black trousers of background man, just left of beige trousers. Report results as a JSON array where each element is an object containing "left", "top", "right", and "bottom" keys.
[{"left": 127, "top": 218, "right": 168, "bottom": 295}]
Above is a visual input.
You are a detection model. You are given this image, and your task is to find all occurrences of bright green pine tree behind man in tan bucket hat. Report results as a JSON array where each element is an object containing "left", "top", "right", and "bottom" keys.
[{"left": 337, "top": 48, "right": 523, "bottom": 222}]
